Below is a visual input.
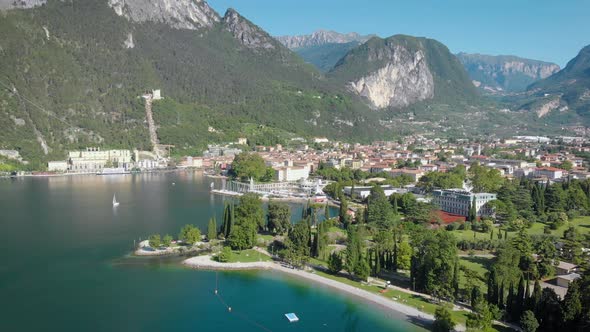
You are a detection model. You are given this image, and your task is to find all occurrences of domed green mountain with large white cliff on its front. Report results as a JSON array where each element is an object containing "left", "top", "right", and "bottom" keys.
[{"left": 328, "top": 35, "right": 477, "bottom": 109}]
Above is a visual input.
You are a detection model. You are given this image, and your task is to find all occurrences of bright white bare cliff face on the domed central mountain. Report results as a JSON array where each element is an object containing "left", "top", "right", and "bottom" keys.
[{"left": 349, "top": 46, "right": 434, "bottom": 108}]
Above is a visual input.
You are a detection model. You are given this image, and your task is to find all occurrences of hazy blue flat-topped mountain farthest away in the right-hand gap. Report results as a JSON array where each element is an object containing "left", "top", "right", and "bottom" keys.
[{"left": 457, "top": 53, "right": 559, "bottom": 94}]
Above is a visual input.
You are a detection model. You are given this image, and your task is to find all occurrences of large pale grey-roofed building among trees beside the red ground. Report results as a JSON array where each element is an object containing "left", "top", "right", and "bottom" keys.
[{"left": 432, "top": 189, "right": 496, "bottom": 217}]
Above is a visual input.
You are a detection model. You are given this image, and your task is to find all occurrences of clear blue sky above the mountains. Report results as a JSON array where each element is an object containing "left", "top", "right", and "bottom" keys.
[{"left": 208, "top": 0, "right": 590, "bottom": 66}]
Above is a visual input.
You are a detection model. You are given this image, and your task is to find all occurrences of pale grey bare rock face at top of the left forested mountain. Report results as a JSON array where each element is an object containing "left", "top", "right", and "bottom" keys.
[{"left": 109, "top": 0, "right": 219, "bottom": 30}]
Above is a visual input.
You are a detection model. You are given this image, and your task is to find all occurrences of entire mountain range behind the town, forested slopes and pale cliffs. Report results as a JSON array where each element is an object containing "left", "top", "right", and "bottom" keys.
[{"left": 0, "top": 0, "right": 587, "bottom": 168}]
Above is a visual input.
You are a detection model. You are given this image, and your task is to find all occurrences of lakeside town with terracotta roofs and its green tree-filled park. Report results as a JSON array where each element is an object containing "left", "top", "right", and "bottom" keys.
[{"left": 3, "top": 132, "right": 590, "bottom": 326}]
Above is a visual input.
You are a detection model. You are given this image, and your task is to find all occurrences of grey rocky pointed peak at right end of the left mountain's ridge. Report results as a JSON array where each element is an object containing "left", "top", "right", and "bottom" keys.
[{"left": 223, "top": 9, "right": 276, "bottom": 50}]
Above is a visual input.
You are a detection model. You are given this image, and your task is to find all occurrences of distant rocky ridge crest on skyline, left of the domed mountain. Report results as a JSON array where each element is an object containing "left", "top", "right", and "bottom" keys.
[{"left": 277, "top": 30, "right": 374, "bottom": 49}]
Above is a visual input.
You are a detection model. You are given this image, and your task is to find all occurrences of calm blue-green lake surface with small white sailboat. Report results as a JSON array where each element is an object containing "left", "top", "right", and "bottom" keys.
[{"left": 0, "top": 172, "right": 423, "bottom": 332}]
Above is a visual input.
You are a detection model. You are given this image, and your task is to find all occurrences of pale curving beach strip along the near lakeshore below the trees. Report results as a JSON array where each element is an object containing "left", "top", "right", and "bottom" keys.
[{"left": 182, "top": 255, "right": 440, "bottom": 327}]
